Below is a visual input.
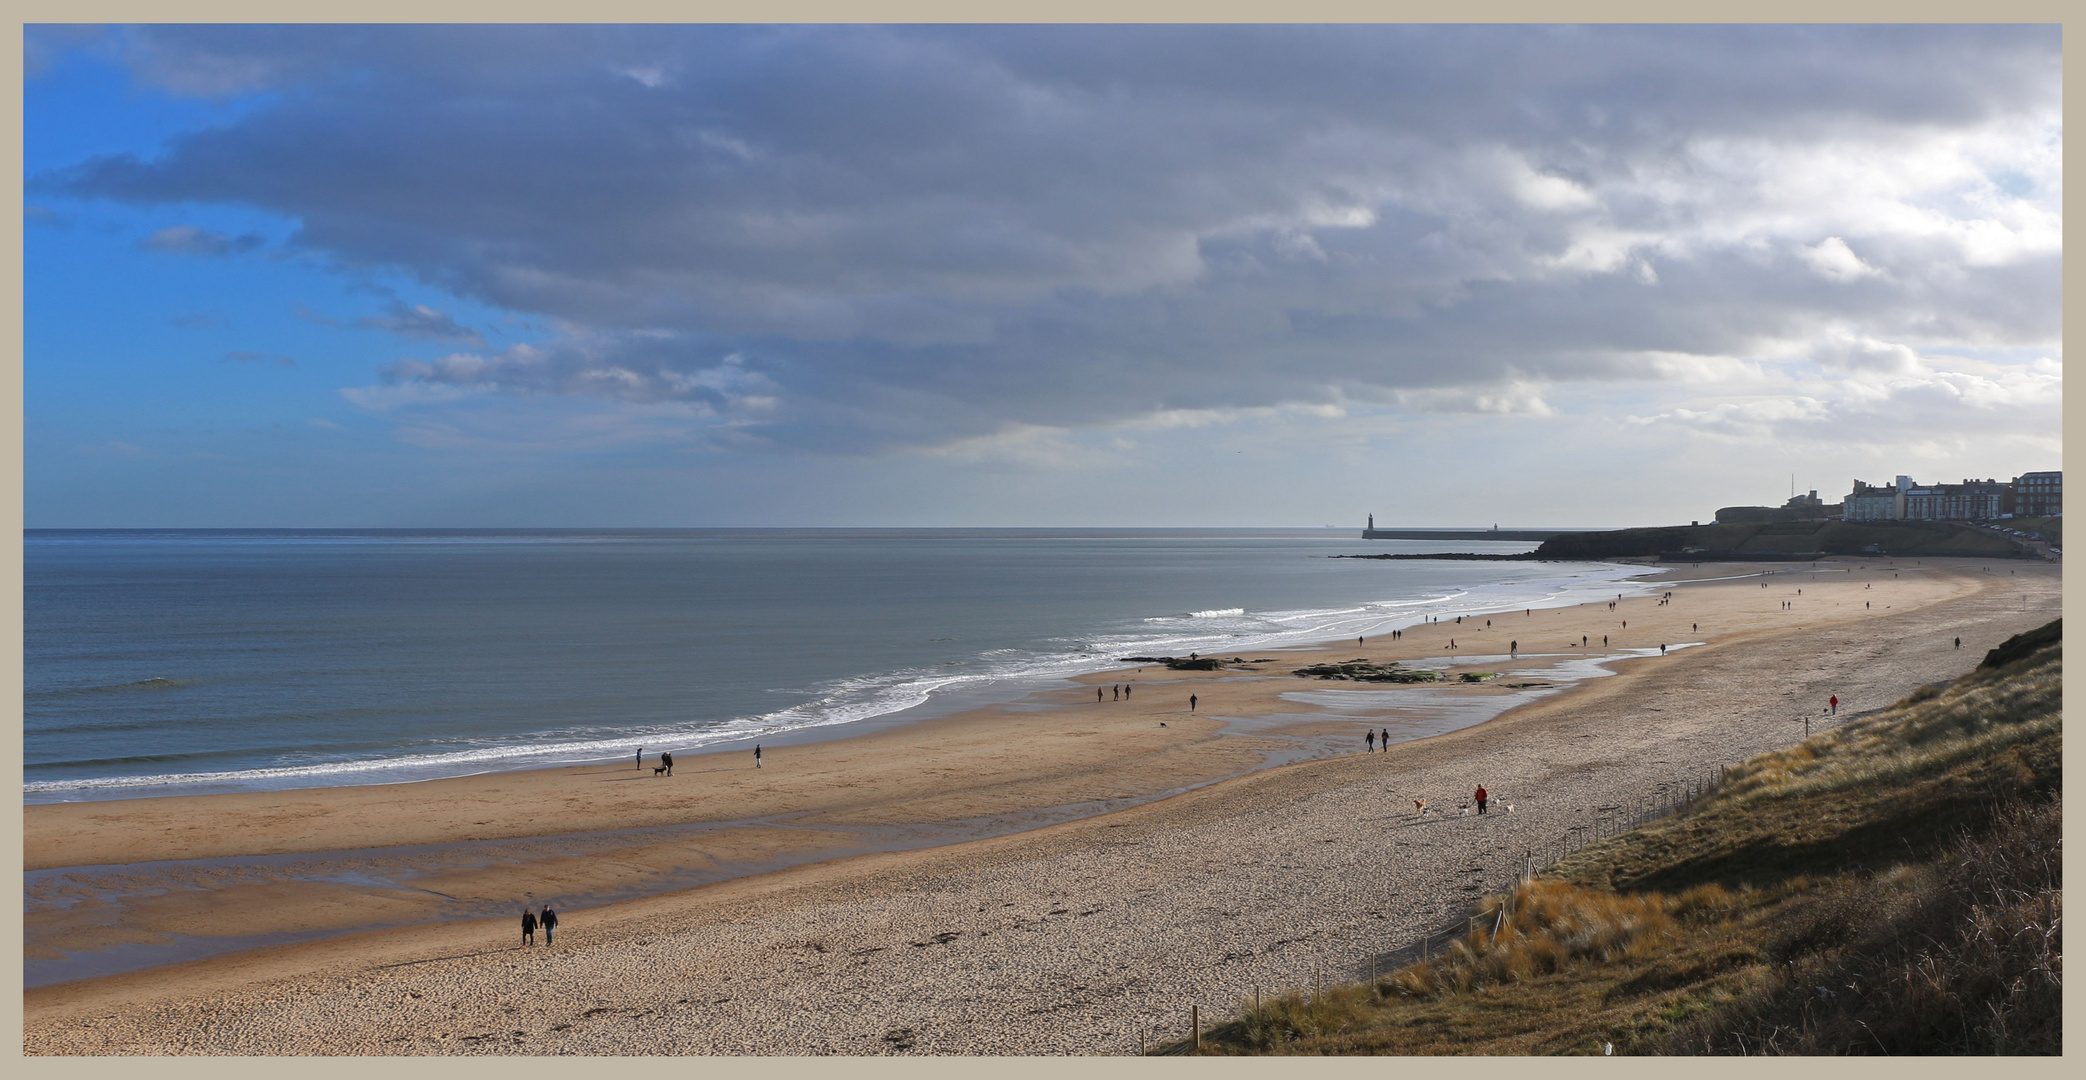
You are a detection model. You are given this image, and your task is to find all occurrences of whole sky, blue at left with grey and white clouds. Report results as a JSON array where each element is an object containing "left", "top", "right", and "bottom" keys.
[{"left": 23, "top": 25, "right": 2063, "bottom": 527}]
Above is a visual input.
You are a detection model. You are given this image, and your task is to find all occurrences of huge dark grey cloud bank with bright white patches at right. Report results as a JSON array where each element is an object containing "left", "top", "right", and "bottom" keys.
[{"left": 35, "top": 27, "right": 2061, "bottom": 450}]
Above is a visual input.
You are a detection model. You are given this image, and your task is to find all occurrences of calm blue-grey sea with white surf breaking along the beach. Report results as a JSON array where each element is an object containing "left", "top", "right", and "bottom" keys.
[{"left": 23, "top": 530, "right": 1650, "bottom": 803}]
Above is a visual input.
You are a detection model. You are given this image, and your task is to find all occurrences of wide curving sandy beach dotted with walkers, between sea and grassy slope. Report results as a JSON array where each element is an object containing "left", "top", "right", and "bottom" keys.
[{"left": 25, "top": 559, "right": 2061, "bottom": 1055}]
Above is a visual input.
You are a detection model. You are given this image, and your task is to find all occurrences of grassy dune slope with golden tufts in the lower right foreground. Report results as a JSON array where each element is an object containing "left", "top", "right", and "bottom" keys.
[{"left": 1162, "top": 623, "right": 2063, "bottom": 1055}]
